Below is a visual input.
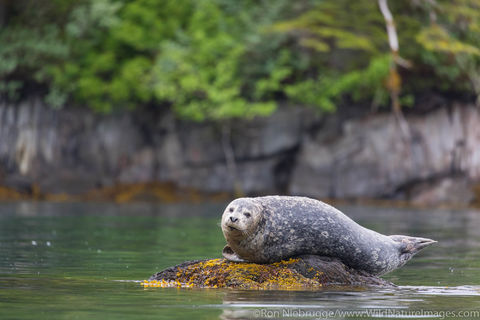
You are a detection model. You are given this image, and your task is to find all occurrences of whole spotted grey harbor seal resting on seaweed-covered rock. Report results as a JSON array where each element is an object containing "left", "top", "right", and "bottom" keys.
[{"left": 221, "top": 196, "right": 436, "bottom": 275}]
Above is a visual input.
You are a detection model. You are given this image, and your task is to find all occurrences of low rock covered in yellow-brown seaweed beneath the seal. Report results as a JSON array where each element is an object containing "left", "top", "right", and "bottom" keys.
[{"left": 142, "top": 255, "right": 395, "bottom": 290}]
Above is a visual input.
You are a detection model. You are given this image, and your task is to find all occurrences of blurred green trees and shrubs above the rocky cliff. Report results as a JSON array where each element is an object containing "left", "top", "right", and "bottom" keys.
[{"left": 0, "top": 0, "right": 480, "bottom": 121}]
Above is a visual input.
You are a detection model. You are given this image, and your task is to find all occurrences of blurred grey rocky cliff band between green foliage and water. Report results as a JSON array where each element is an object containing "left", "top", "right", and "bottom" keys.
[{"left": 0, "top": 98, "right": 480, "bottom": 205}]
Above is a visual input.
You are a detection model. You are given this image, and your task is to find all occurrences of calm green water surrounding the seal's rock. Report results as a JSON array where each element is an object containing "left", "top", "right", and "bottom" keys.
[{"left": 0, "top": 202, "right": 480, "bottom": 320}]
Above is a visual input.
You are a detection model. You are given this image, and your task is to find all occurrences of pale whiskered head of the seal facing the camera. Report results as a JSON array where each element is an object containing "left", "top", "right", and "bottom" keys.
[{"left": 222, "top": 198, "right": 263, "bottom": 242}]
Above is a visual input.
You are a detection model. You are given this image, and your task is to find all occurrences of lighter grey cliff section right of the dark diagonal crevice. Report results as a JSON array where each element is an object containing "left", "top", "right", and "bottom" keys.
[{"left": 290, "top": 105, "right": 480, "bottom": 202}]
